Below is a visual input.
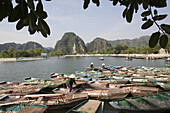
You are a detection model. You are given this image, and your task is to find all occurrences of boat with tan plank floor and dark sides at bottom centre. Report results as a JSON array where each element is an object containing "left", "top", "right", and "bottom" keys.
[{"left": 66, "top": 100, "right": 104, "bottom": 113}]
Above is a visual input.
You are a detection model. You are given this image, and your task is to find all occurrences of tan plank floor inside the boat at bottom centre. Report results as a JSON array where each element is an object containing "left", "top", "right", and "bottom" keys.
[{"left": 77, "top": 100, "right": 101, "bottom": 113}]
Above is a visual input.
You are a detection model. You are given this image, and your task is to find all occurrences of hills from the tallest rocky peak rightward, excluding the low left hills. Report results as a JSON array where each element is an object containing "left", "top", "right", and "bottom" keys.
[{"left": 54, "top": 32, "right": 149, "bottom": 54}]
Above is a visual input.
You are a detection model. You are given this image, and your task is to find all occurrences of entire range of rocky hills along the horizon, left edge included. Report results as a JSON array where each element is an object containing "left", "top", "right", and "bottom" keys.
[{"left": 0, "top": 32, "right": 150, "bottom": 54}]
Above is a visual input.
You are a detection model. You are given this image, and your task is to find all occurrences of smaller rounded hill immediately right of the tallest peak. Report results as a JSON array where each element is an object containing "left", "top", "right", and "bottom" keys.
[{"left": 87, "top": 38, "right": 112, "bottom": 52}]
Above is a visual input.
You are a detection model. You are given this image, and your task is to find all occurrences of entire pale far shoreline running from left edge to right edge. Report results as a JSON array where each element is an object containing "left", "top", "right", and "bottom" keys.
[{"left": 0, "top": 54, "right": 170, "bottom": 62}]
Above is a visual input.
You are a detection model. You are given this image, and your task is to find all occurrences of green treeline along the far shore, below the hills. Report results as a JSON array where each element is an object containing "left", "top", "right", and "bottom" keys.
[{"left": 0, "top": 43, "right": 170, "bottom": 58}]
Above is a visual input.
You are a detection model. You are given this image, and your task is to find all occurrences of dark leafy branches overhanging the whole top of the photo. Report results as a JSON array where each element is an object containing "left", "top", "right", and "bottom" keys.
[{"left": 0, "top": 0, "right": 170, "bottom": 48}]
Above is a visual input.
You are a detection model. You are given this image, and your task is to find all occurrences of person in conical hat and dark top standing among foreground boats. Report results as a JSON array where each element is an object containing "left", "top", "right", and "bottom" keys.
[{"left": 66, "top": 74, "right": 76, "bottom": 92}]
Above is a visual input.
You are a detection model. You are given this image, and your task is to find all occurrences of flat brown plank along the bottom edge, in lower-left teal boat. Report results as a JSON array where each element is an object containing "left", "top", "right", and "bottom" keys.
[{"left": 18, "top": 106, "right": 47, "bottom": 113}]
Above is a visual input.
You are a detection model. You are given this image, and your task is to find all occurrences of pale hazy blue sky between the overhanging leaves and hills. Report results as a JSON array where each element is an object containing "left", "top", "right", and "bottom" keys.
[{"left": 0, "top": 0, "right": 170, "bottom": 47}]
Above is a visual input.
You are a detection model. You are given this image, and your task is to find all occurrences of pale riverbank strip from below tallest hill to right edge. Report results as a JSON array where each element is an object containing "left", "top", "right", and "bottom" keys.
[{"left": 65, "top": 54, "right": 170, "bottom": 59}]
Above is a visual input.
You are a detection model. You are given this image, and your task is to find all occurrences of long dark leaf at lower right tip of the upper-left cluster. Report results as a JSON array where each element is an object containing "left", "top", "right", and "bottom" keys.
[{"left": 38, "top": 19, "right": 50, "bottom": 35}]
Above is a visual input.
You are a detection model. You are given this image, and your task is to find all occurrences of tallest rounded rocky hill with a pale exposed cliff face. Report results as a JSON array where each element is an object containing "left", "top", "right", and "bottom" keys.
[{"left": 54, "top": 32, "right": 87, "bottom": 54}]
